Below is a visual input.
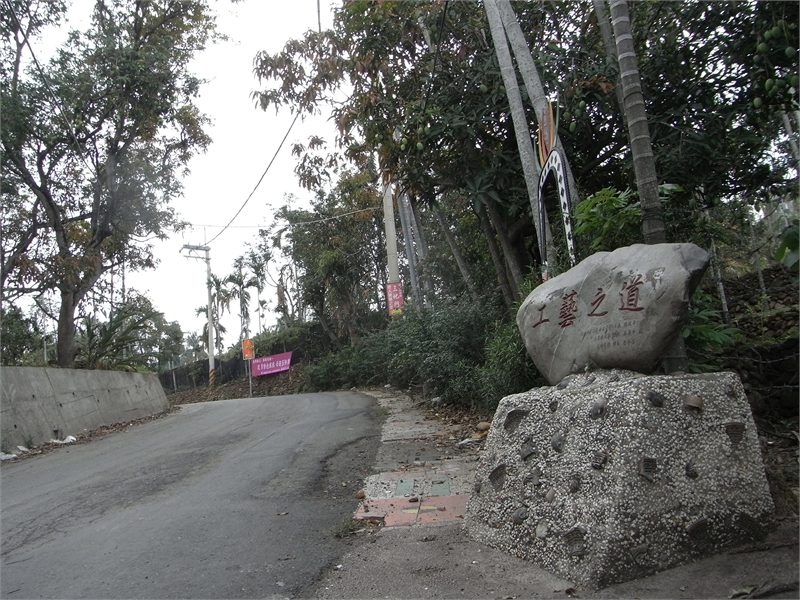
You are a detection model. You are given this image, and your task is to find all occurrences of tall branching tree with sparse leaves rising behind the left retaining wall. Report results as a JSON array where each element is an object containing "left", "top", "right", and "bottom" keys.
[{"left": 0, "top": 0, "right": 214, "bottom": 367}]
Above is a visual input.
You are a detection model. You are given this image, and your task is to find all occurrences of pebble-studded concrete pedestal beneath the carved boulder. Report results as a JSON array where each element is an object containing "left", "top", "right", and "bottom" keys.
[{"left": 466, "top": 369, "right": 774, "bottom": 588}]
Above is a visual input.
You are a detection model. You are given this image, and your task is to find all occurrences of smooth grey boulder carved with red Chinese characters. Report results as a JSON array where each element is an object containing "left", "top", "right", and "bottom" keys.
[{"left": 517, "top": 244, "right": 709, "bottom": 385}]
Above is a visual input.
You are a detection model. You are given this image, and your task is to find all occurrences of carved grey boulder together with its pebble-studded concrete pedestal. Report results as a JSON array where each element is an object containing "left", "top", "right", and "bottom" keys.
[{"left": 466, "top": 244, "right": 774, "bottom": 588}]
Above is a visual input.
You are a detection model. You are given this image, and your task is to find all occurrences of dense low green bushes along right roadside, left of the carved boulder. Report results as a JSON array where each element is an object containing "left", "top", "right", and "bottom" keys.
[{"left": 305, "top": 301, "right": 544, "bottom": 410}]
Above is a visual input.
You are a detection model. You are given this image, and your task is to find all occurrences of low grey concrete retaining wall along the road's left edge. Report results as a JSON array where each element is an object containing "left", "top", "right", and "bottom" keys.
[{"left": 0, "top": 367, "right": 169, "bottom": 450}]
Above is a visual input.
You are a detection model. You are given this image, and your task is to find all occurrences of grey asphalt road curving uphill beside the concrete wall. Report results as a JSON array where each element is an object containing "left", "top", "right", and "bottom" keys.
[{"left": 0, "top": 392, "right": 380, "bottom": 599}]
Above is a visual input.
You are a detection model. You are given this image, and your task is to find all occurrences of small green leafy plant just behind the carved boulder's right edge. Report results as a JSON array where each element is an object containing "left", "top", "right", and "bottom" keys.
[{"left": 682, "top": 290, "right": 740, "bottom": 373}]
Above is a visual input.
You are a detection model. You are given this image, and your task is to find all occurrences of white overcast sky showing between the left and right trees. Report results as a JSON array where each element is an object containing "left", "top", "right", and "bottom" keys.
[{"left": 47, "top": 0, "right": 336, "bottom": 348}]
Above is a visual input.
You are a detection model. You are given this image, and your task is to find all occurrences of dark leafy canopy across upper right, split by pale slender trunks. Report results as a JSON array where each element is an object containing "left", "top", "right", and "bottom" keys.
[{"left": 254, "top": 0, "right": 798, "bottom": 310}]
